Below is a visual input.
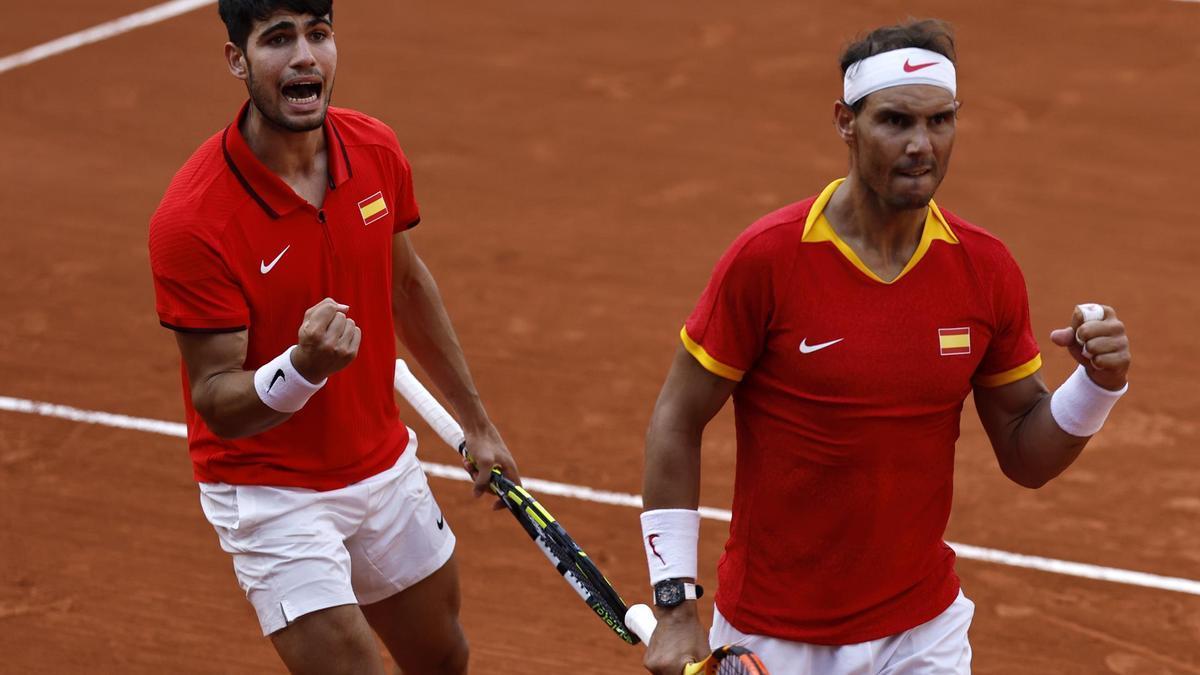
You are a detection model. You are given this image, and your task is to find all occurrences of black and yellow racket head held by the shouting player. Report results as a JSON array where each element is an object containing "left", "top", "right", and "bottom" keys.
[{"left": 491, "top": 468, "right": 638, "bottom": 645}]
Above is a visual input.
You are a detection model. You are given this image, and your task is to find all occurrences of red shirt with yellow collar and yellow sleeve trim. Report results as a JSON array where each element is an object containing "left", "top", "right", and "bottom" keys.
[{"left": 682, "top": 180, "right": 1042, "bottom": 645}]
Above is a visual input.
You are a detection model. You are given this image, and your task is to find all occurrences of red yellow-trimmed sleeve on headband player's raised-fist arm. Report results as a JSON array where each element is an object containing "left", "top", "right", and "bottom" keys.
[{"left": 973, "top": 243, "right": 1042, "bottom": 387}]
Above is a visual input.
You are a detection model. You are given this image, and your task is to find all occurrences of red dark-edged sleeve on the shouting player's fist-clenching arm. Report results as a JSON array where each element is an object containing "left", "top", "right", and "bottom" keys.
[{"left": 150, "top": 219, "right": 250, "bottom": 333}]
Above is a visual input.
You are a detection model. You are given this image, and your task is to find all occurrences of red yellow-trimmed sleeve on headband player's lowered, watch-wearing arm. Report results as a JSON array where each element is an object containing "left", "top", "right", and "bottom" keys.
[{"left": 679, "top": 232, "right": 774, "bottom": 381}]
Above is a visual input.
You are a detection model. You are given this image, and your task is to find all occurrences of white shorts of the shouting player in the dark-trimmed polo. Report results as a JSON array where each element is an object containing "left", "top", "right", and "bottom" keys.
[{"left": 200, "top": 429, "right": 455, "bottom": 635}]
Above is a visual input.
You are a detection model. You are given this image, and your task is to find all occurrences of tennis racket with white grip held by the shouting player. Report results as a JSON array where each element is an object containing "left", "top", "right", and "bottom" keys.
[{"left": 395, "top": 359, "right": 638, "bottom": 645}]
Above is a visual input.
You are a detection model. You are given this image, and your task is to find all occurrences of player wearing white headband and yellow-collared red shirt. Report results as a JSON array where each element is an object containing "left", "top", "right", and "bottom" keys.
[{"left": 642, "top": 20, "right": 1130, "bottom": 675}]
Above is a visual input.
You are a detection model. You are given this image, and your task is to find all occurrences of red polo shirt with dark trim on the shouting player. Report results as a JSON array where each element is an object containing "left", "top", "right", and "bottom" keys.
[{"left": 150, "top": 104, "right": 420, "bottom": 490}]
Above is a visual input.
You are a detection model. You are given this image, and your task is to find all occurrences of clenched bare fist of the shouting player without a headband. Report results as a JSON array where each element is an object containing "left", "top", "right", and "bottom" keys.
[{"left": 292, "top": 298, "right": 362, "bottom": 384}]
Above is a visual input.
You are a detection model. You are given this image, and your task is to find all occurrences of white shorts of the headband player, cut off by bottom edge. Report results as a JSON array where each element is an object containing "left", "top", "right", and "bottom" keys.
[{"left": 708, "top": 591, "right": 974, "bottom": 675}]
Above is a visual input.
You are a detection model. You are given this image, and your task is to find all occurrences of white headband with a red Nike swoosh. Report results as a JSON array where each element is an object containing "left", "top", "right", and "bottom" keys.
[{"left": 842, "top": 47, "right": 958, "bottom": 106}]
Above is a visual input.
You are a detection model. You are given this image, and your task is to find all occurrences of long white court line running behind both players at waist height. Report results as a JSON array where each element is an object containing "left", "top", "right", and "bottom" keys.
[{"left": 7, "top": 396, "right": 1200, "bottom": 596}]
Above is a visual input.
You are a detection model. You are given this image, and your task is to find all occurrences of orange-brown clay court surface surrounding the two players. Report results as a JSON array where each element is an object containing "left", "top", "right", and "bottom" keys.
[{"left": 0, "top": 0, "right": 1200, "bottom": 675}]
